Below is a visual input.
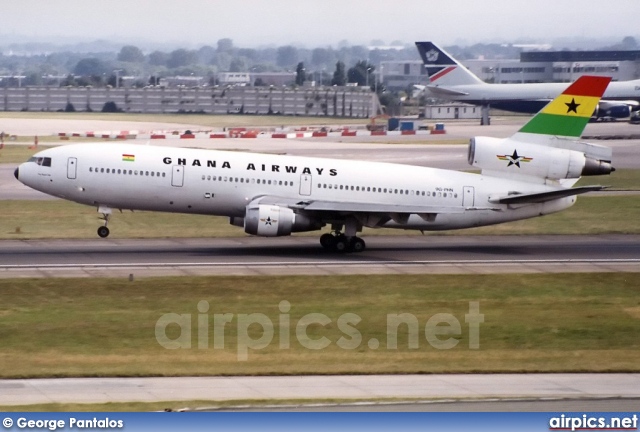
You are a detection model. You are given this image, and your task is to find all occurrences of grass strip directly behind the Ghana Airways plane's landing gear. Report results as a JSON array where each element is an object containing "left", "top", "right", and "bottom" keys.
[{"left": 0, "top": 195, "right": 640, "bottom": 240}]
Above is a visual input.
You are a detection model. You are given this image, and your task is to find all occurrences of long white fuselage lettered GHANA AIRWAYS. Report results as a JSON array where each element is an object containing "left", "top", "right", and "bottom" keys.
[{"left": 18, "top": 143, "right": 576, "bottom": 230}]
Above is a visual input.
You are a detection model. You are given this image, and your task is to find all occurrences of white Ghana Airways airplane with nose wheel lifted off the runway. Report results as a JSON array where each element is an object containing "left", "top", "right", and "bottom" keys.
[{"left": 14, "top": 76, "right": 614, "bottom": 252}]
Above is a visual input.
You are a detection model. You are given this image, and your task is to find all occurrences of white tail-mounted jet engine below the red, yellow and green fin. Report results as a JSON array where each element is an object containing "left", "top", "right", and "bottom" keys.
[{"left": 468, "top": 137, "right": 614, "bottom": 180}]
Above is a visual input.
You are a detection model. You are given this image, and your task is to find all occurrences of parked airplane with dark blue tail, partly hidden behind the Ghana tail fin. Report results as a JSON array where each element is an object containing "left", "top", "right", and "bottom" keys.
[{"left": 416, "top": 42, "right": 640, "bottom": 119}]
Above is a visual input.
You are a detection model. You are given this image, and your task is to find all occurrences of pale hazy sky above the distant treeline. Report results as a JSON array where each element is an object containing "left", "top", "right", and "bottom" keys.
[{"left": 0, "top": 0, "right": 640, "bottom": 48}]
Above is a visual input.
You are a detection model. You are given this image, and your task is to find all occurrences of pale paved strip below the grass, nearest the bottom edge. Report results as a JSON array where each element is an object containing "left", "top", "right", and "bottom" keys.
[{"left": 0, "top": 373, "right": 640, "bottom": 409}]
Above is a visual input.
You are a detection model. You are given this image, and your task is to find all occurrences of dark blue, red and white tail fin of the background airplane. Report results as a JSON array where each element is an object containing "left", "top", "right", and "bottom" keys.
[{"left": 416, "top": 42, "right": 484, "bottom": 86}]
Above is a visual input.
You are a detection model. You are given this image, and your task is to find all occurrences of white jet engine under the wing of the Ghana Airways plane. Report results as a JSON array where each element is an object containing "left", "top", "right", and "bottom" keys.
[{"left": 235, "top": 204, "right": 323, "bottom": 237}]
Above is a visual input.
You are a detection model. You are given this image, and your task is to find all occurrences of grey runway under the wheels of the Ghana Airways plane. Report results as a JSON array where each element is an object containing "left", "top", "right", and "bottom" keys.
[{"left": 0, "top": 235, "right": 640, "bottom": 278}]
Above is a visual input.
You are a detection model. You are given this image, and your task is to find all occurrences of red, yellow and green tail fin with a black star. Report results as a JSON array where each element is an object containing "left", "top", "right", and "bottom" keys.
[{"left": 518, "top": 75, "right": 611, "bottom": 137}]
